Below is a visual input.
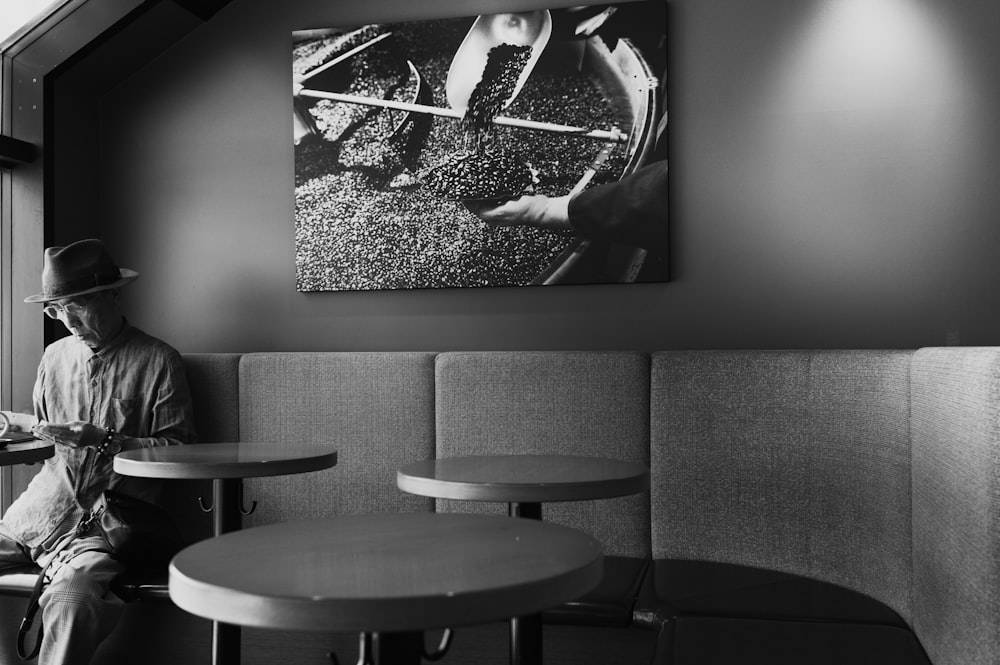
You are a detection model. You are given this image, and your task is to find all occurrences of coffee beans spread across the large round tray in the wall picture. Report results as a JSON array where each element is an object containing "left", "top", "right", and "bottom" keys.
[{"left": 293, "top": 19, "right": 630, "bottom": 291}]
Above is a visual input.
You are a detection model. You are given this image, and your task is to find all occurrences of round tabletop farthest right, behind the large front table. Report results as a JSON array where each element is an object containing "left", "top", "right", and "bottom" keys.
[{"left": 396, "top": 455, "right": 649, "bottom": 503}]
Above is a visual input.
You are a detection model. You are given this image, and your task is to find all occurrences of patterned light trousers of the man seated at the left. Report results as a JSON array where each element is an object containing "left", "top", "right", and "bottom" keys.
[{"left": 0, "top": 521, "right": 124, "bottom": 665}]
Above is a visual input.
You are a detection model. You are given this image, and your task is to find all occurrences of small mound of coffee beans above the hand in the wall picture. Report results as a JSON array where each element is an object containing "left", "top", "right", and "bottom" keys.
[{"left": 424, "top": 150, "right": 532, "bottom": 200}]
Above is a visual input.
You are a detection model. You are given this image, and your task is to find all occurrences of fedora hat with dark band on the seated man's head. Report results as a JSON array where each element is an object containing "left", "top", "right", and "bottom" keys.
[{"left": 24, "top": 239, "right": 139, "bottom": 302}]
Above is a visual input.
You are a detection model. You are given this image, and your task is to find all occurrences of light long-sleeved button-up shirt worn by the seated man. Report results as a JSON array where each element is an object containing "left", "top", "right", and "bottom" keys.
[{"left": 3, "top": 322, "right": 196, "bottom": 549}]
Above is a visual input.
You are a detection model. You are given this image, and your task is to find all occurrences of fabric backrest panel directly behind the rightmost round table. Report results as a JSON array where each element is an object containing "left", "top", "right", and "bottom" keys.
[{"left": 436, "top": 351, "right": 650, "bottom": 557}]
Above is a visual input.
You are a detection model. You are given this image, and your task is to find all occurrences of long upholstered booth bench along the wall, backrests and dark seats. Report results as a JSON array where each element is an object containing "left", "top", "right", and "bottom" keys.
[{"left": 0, "top": 347, "right": 1000, "bottom": 665}]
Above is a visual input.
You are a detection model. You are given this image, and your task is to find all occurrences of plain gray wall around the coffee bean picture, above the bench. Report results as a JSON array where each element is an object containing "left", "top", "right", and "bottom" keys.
[{"left": 90, "top": 0, "right": 1000, "bottom": 352}]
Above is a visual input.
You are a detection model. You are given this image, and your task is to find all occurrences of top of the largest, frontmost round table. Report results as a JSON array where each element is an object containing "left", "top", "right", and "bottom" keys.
[{"left": 170, "top": 513, "right": 603, "bottom": 632}]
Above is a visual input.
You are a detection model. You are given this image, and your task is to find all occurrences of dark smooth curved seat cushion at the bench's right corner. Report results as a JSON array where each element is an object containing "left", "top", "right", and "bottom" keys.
[{"left": 636, "top": 559, "right": 930, "bottom": 665}]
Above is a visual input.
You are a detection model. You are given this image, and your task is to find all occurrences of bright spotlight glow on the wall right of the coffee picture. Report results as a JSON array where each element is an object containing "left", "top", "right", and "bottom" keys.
[{"left": 756, "top": 0, "right": 981, "bottom": 286}]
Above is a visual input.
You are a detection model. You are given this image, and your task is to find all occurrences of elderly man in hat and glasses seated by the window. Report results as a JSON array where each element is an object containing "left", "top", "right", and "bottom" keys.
[{"left": 0, "top": 240, "right": 195, "bottom": 665}]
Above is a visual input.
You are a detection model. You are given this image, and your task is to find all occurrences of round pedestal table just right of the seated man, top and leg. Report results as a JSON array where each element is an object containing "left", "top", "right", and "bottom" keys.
[{"left": 114, "top": 442, "right": 337, "bottom": 665}]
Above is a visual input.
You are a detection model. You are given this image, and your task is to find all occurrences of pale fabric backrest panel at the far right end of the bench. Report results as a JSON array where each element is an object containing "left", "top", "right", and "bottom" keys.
[{"left": 912, "top": 347, "right": 1000, "bottom": 665}]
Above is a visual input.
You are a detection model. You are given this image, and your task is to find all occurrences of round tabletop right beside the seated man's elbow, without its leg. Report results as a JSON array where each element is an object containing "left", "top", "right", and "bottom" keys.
[{"left": 114, "top": 442, "right": 337, "bottom": 479}]
